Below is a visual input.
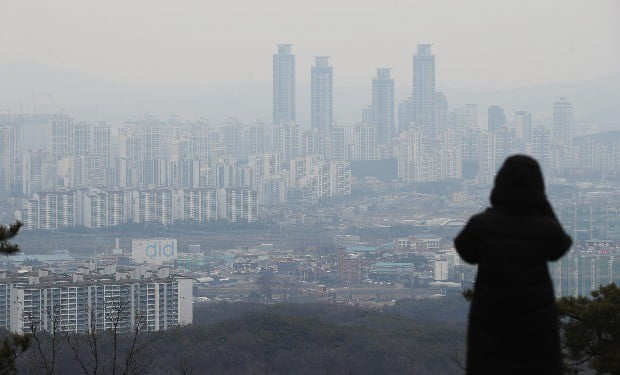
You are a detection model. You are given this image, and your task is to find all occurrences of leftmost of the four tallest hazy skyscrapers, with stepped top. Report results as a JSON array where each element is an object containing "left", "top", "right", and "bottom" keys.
[{"left": 273, "top": 44, "right": 295, "bottom": 124}]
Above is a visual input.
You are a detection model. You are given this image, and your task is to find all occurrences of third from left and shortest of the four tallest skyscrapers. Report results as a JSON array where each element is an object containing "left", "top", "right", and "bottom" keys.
[{"left": 371, "top": 68, "right": 395, "bottom": 144}]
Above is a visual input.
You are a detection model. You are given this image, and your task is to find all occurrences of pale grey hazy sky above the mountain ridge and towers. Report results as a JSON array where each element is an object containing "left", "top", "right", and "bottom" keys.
[{"left": 0, "top": 0, "right": 620, "bottom": 89}]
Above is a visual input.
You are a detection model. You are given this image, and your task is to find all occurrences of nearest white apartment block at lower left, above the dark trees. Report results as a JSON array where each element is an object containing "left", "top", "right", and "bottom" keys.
[{"left": 0, "top": 269, "right": 193, "bottom": 334}]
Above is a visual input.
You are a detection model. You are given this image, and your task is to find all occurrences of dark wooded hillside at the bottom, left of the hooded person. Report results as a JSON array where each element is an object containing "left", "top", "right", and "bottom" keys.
[{"left": 4, "top": 298, "right": 465, "bottom": 374}]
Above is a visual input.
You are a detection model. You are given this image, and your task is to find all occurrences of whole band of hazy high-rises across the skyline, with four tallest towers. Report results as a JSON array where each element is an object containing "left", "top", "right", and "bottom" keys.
[{"left": 0, "top": 44, "right": 620, "bottom": 228}]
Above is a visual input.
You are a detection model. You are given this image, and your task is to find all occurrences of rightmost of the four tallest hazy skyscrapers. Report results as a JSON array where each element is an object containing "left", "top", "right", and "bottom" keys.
[{"left": 412, "top": 44, "right": 436, "bottom": 138}]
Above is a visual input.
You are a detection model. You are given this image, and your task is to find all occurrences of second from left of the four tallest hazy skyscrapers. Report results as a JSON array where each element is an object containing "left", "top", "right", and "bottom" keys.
[{"left": 310, "top": 56, "right": 334, "bottom": 131}]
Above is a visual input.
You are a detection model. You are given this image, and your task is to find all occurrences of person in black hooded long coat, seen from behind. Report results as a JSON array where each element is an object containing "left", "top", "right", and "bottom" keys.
[{"left": 454, "top": 155, "right": 572, "bottom": 374}]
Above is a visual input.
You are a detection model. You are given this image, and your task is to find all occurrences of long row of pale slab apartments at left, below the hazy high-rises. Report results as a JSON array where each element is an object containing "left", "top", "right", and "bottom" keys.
[{"left": 15, "top": 187, "right": 256, "bottom": 230}]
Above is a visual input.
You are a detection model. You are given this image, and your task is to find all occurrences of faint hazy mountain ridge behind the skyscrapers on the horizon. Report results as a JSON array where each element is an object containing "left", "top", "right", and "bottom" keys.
[{"left": 0, "top": 63, "right": 620, "bottom": 133}]
